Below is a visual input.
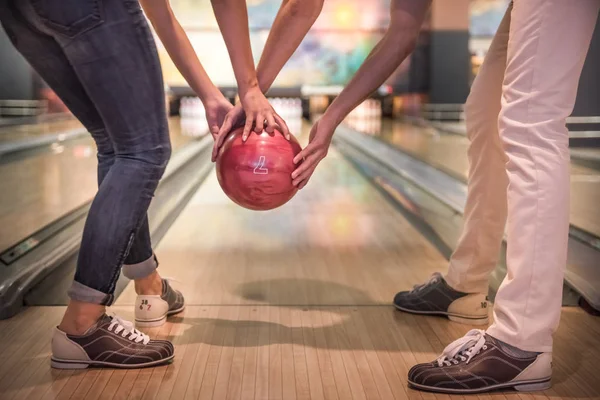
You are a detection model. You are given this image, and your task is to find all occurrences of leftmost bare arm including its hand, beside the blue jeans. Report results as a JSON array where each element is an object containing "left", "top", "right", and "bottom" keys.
[{"left": 140, "top": 0, "right": 233, "bottom": 137}]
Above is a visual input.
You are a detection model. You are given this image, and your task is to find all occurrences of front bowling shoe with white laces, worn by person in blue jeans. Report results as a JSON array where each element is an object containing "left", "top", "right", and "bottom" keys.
[{"left": 51, "top": 314, "right": 174, "bottom": 369}]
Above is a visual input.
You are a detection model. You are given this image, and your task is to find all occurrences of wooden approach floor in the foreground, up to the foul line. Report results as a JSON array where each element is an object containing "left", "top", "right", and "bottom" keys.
[{"left": 0, "top": 305, "right": 600, "bottom": 400}]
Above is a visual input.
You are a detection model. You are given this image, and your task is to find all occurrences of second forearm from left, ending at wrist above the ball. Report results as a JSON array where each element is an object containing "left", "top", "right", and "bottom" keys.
[{"left": 211, "top": 0, "right": 258, "bottom": 97}]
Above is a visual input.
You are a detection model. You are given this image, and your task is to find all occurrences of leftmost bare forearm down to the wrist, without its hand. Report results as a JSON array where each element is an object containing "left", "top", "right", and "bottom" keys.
[{"left": 140, "top": 0, "right": 221, "bottom": 102}]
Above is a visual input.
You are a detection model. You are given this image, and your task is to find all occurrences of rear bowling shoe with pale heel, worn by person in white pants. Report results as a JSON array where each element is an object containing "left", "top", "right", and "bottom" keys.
[{"left": 394, "top": 272, "right": 488, "bottom": 325}]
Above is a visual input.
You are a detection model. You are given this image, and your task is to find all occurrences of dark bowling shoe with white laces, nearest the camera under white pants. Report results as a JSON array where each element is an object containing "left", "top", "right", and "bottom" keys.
[{"left": 408, "top": 329, "right": 552, "bottom": 394}]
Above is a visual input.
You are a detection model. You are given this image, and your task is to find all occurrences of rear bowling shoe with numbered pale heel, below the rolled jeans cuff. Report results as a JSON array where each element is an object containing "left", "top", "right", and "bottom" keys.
[{"left": 135, "top": 279, "right": 185, "bottom": 328}]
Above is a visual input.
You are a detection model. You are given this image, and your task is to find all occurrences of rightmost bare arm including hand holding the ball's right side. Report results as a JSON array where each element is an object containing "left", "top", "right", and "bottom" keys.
[{"left": 292, "top": 0, "right": 431, "bottom": 188}]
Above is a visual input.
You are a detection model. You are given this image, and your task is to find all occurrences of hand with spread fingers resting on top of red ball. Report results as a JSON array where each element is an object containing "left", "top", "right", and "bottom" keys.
[{"left": 240, "top": 86, "right": 290, "bottom": 141}]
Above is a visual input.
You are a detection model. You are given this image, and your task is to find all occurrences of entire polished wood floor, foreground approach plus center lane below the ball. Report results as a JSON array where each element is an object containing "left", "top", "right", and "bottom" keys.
[{"left": 0, "top": 122, "right": 600, "bottom": 400}]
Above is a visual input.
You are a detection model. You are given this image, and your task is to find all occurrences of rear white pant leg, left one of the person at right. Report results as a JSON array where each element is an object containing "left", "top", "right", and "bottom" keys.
[{"left": 445, "top": 7, "right": 510, "bottom": 294}]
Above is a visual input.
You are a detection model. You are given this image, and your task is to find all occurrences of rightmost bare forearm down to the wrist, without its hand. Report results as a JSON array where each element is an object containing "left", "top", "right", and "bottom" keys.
[{"left": 324, "top": 0, "right": 431, "bottom": 126}]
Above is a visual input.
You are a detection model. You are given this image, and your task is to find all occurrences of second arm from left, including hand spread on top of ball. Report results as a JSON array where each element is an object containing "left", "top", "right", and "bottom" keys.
[{"left": 212, "top": 0, "right": 289, "bottom": 140}]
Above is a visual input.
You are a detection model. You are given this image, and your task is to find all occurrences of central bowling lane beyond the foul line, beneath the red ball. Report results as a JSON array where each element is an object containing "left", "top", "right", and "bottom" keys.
[{"left": 117, "top": 119, "right": 446, "bottom": 306}]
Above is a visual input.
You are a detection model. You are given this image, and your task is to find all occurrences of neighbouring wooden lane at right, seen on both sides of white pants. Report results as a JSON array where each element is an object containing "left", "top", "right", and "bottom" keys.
[{"left": 360, "top": 120, "right": 600, "bottom": 242}]
